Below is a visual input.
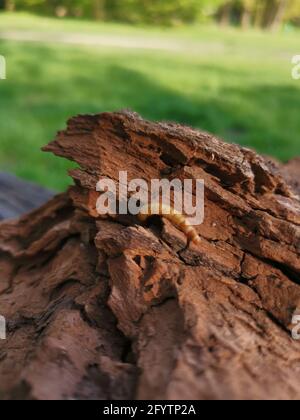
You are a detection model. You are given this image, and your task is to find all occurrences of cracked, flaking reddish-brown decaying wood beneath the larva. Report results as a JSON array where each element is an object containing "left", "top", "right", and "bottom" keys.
[{"left": 0, "top": 112, "right": 300, "bottom": 399}]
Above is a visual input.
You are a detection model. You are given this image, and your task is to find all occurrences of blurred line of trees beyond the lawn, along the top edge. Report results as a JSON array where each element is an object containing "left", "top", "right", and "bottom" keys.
[{"left": 0, "top": 0, "right": 300, "bottom": 30}]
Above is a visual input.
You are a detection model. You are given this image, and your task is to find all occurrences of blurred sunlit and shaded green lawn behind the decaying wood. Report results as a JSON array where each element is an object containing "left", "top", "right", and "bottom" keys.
[{"left": 0, "top": 14, "right": 300, "bottom": 190}]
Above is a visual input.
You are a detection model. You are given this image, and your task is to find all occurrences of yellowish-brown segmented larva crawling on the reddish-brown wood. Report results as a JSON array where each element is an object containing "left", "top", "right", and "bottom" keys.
[{"left": 138, "top": 204, "right": 201, "bottom": 244}]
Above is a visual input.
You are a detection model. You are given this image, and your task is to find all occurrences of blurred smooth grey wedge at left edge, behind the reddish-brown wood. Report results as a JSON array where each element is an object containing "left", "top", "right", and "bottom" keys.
[{"left": 0, "top": 172, "right": 53, "bottom": 220}]
